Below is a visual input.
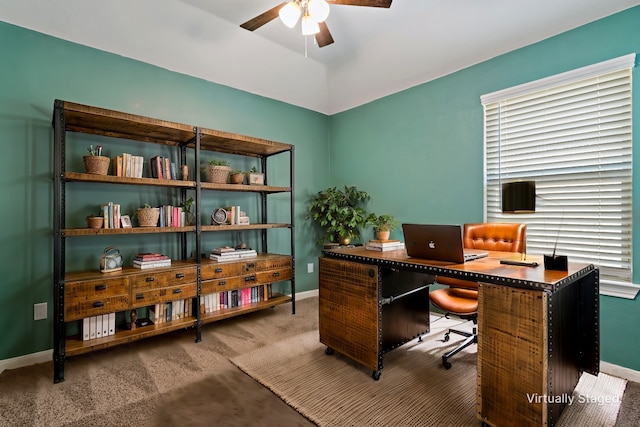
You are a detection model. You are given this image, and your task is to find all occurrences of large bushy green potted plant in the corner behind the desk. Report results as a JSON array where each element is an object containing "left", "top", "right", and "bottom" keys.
[{"left": 305, "top": 185, "right": 371, "bottom": 245}]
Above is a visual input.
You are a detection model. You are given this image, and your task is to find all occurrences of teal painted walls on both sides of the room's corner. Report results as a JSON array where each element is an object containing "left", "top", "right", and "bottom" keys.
[{"left": 0, "top": 7, "right": 640, "bottom": 370}]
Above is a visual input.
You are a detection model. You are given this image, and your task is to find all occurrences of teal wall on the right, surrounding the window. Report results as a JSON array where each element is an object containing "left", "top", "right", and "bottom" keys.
[{"left": 330, "top": 7, "right": 640, "bottom": 370}]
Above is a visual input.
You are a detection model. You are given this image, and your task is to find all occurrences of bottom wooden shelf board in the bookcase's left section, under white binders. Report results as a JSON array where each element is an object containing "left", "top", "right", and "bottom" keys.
[{"left": 66, "top": 317, "right": 196, "bottom": 356}]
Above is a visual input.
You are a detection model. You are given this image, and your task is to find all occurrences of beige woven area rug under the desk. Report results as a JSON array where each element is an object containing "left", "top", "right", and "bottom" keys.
[{"left": 231, "top": 330, "right": 626, "bottom": 427}]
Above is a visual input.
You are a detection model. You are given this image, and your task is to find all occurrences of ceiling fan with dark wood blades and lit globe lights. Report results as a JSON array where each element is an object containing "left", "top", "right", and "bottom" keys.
[{"left": 240, "top": 0, "right": 392, "bottom": 47}]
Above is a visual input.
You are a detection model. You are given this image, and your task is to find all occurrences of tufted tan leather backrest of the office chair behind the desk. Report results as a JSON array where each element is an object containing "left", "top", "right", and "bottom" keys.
[{"left": 436, "top": 222, "right": 527, "bottom": 289}]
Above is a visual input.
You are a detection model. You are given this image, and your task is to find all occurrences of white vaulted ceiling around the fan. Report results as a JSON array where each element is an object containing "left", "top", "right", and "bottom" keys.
[{"left": 0, "top": 0, "right": 640, "bottom": 114}]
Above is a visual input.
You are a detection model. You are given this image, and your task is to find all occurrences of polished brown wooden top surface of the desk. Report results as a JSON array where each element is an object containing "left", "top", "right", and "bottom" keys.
[{"left": 323, "top": 246, "right": 596, "bottom": 292}]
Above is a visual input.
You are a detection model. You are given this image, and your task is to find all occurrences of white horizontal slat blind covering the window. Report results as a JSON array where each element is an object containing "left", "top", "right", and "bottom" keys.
[{"left": 482, "top": 54, "right": 635, "bottom": 283}]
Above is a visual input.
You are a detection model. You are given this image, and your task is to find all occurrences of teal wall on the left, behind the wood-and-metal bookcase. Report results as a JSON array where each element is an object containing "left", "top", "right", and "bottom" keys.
[{"left": 0, "top": 22, "right": 330, "bottom": 360}]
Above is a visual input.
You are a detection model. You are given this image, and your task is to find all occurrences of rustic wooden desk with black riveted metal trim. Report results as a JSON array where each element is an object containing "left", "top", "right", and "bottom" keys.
[{"left": 319, "top": 247, "right": 600, "bottom": 426}]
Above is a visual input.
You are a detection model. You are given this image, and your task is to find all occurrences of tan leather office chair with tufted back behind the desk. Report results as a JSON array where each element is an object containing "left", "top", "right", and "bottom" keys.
[{"left": 429, "top": 223, "right": 527, "bottom": 369}]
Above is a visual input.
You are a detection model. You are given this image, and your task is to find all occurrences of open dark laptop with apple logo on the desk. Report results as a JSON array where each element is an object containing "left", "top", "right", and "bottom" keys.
[{"left": 402, "top": 224, "right": 489, "bottom": 264}]
